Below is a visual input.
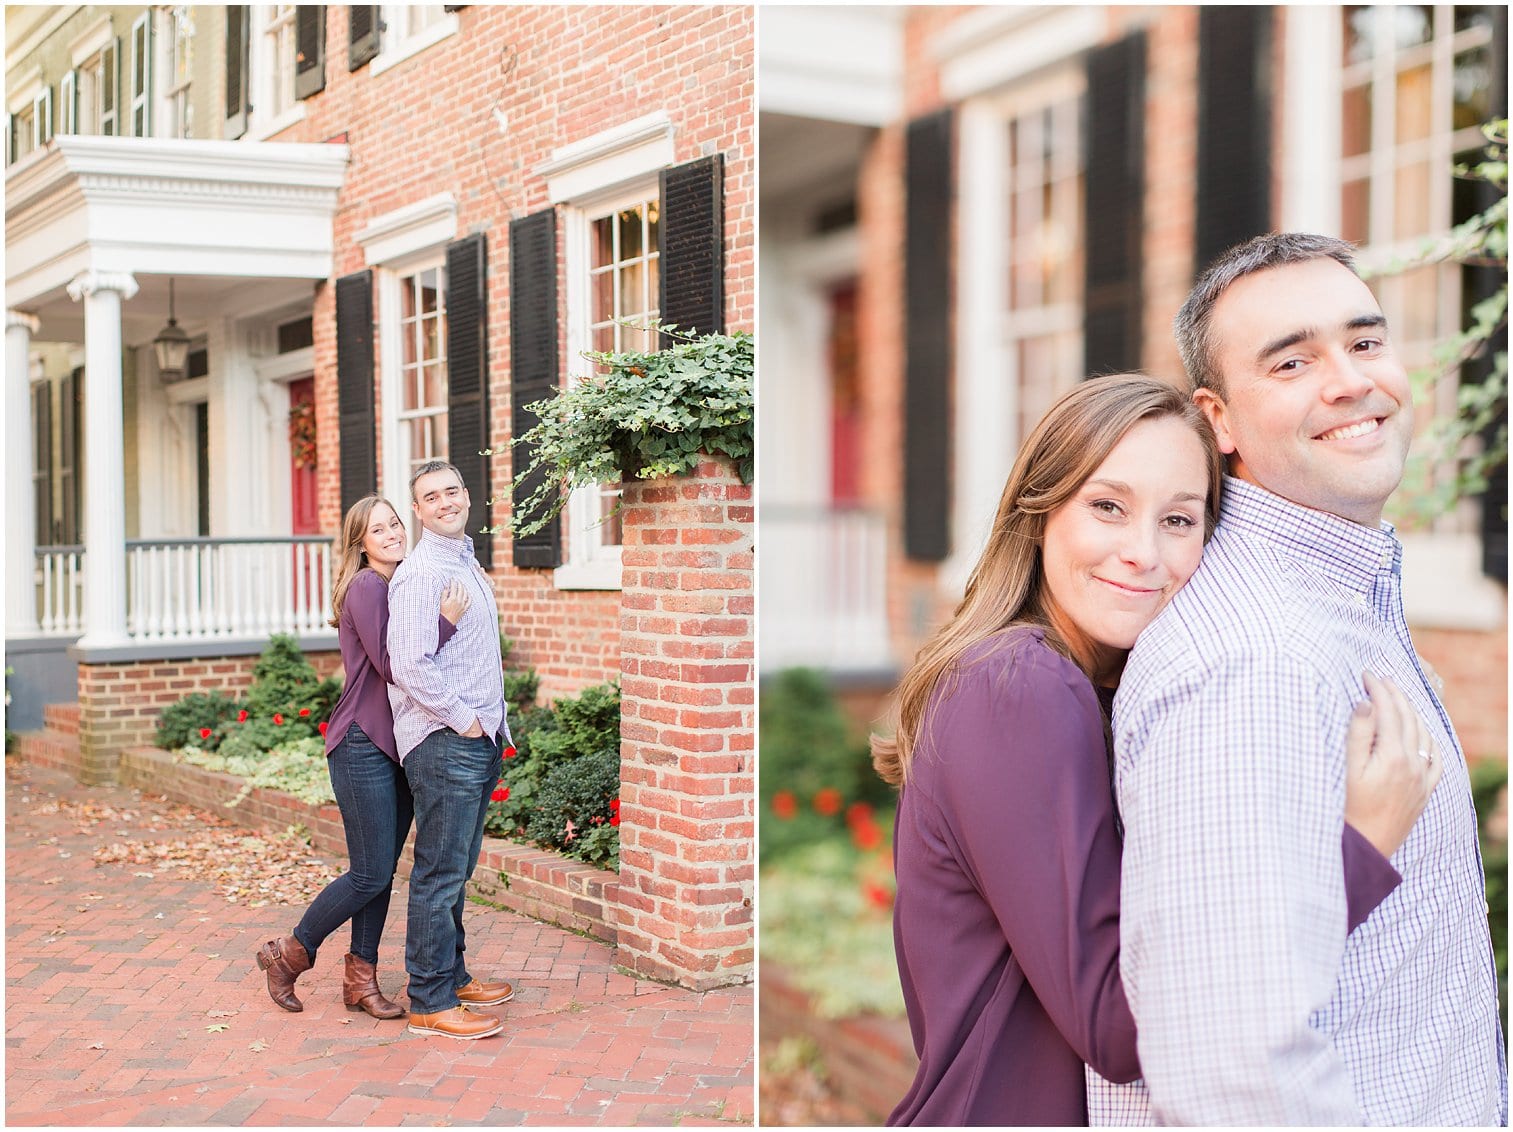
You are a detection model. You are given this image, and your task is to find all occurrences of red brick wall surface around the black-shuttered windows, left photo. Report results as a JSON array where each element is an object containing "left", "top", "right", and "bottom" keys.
[{"left": 277, "top": 5, "right": 755, "bottom": 699}]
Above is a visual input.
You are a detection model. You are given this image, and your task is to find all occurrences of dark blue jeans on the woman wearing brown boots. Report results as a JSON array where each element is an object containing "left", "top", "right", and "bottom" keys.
[{"left": 294, "top": 723, "right": 415, "bottom": 964}]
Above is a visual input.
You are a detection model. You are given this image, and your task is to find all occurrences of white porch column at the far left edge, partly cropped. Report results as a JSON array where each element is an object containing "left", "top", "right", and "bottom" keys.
[{"left": 5, "top": 310, "right": 41, "bottom": 637}]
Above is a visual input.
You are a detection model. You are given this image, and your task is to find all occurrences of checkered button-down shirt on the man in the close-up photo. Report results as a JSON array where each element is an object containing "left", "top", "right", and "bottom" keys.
[{"left": 1088, "top": 478, "right": 1507, "bottom": 1124}]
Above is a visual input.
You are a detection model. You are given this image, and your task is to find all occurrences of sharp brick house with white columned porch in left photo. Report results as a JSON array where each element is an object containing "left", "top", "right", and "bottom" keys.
[{"left": 5, "top": 5, "right": 755, "bottom": 742}]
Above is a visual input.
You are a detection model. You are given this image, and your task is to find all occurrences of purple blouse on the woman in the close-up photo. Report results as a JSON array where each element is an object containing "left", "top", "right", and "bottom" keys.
[{"left": 888, "top": 628, "right": 1400, "bottom": 1126}]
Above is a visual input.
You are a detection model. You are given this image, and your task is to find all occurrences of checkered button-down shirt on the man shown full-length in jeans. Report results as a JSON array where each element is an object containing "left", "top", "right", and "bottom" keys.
[{"left": 389, "top": 530, "right": 510, "bottom": 763}]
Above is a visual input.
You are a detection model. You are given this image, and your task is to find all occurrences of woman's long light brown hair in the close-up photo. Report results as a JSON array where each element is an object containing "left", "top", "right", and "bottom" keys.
[{"left": 871, "top": 374, "right": 1224, "bottom": 785}]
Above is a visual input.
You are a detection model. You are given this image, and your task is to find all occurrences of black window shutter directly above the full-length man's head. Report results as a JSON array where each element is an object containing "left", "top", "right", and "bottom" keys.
[{"left": 446, "top": 232, "right": 493, "bottom": 571}]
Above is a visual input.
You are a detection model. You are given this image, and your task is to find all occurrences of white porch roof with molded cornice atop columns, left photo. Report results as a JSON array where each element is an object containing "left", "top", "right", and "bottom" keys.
[{"left": 5, "top": 135, "right": 348, "bottom": 344}]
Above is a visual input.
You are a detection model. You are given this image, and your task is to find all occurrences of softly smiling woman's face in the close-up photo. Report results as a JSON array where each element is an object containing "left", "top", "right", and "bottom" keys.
[{"left": 1041, "top": 416, "right": 1209, "bottom": 655}]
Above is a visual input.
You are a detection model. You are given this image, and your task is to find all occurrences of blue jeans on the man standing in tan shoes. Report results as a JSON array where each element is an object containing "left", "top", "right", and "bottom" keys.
[{"left": 404, "top": 728, "right": 501, "bottom": 1014}]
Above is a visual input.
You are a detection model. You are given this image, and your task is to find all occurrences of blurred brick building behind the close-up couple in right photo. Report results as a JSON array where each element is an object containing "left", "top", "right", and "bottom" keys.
[{"left": 760, "top": 6, "right": 1507, "bottom": 757}]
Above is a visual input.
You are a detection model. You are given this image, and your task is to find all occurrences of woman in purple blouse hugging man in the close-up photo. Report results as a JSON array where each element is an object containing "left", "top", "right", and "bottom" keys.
[{"left": 873, "top": 375, "right": 1439, "bottom": 1124}]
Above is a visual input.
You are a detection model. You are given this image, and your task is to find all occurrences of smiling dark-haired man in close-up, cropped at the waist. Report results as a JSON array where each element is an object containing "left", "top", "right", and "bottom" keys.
[{"left": 1088, "top": 233, "right": 1507, "bottom": 1124}]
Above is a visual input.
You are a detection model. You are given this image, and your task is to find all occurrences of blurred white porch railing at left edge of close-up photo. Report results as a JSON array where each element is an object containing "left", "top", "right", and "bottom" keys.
[{"left": 758, "top": 504, "right": 893, "bottom": 672}]
